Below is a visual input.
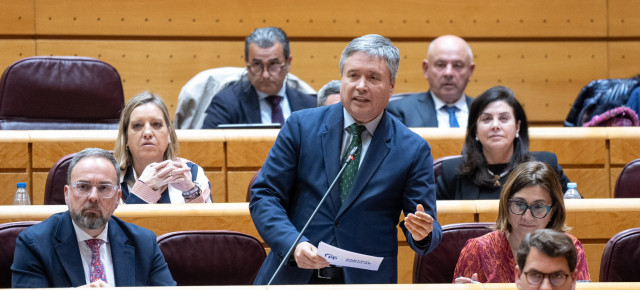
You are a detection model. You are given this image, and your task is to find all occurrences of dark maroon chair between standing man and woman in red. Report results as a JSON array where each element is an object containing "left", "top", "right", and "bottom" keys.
[{"left": 413, "top": 223, "right": 495, "bottom": 283}]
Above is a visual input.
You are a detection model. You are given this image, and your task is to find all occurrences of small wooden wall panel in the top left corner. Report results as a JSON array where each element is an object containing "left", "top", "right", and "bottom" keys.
[{"left": 0, "top": 0, "right": 35, "bottom": 35}]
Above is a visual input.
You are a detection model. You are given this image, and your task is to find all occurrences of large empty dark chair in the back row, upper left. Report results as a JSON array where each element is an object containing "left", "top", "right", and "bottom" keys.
[{"left": 0, "top": 56, "right": 124, "bottom": 130}]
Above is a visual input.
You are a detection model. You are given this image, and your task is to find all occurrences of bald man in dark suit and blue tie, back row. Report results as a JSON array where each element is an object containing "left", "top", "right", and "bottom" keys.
[{"left": 387, "top": 35, "right": 475, "bottom": 128}]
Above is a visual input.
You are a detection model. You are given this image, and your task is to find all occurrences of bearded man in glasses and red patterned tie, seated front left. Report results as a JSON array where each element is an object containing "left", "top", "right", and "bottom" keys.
[{"left": 11, "top": 148, "right": 176, "bottom": 288}]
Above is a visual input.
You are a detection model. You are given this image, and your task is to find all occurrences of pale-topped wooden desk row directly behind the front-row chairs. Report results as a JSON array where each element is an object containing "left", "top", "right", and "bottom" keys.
[{"left": 0, "top": 199, "right": 640, "bottom": 283}]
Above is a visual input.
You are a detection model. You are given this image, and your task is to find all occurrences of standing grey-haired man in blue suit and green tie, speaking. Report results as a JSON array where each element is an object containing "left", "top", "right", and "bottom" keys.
[{"left": 249, "top": 35, "right": 442, "bottom": 284}]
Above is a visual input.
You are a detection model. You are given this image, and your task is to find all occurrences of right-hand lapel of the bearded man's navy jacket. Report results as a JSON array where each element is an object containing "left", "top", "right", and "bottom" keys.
[{"left": 107, "top": 218, "right": 136, "bottom": 286}]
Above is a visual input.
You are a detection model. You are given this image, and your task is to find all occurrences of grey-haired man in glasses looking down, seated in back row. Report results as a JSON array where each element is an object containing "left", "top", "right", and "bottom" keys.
[{"left": 202, "top": 27, "right": 316, "bottom": 129}]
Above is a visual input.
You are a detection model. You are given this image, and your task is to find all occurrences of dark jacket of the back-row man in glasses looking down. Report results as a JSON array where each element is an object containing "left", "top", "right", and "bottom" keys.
[{"left": 202, "top": 81, "right": 317, "bottom": 129}]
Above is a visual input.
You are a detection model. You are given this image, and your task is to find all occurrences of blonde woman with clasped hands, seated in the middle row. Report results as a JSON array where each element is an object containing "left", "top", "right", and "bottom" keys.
[{"left": 113, "top": 91, "right": 212, "bottom": 203}]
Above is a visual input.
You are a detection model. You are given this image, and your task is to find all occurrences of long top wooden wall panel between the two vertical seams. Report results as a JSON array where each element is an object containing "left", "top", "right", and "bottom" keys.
[{"left": 36, "top": 0, "right": 607, "bottom": 37}]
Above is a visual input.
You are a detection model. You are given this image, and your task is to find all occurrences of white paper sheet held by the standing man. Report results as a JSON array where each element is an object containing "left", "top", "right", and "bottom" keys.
[{"left": 318, "top": 242, "right": 384, "bottom": 271}]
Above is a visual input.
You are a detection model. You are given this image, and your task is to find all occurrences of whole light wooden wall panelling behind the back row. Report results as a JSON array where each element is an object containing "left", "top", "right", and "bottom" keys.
[{"left": 0, "top": 0, "right": 640, "bottom": 125}]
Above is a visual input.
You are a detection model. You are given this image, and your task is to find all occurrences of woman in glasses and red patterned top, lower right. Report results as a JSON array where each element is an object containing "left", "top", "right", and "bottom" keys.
[{"left": 453, "top": 161, "right": 591, "bottom": 283}]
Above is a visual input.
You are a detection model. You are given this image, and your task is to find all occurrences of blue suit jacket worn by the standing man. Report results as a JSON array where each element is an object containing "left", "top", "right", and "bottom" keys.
[{"left": 249, "top": 104, "right": 442, "bottom": 284}]
